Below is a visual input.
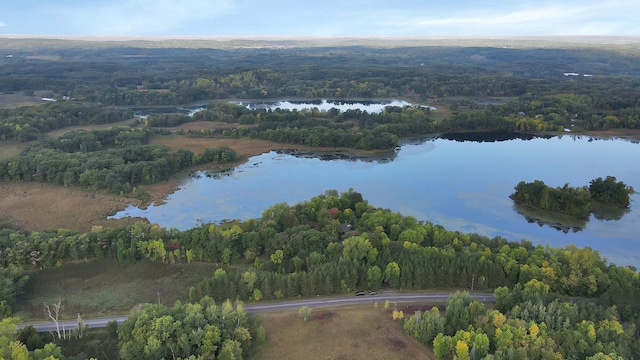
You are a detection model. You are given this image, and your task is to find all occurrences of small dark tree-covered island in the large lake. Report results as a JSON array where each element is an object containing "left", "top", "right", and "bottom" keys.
[{"left": 510, "top": 176, "right": 633, "bottom": 219}]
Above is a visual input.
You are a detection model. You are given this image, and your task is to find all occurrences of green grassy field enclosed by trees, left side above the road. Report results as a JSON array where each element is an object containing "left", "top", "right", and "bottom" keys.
[{"left": 18, "top": 260, "right": 216, "bottom": 320}]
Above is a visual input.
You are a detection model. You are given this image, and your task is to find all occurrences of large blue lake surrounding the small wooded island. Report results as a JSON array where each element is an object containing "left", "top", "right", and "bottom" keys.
[{"left": 111, "top": 135, "right": 640, "bottom": 268}]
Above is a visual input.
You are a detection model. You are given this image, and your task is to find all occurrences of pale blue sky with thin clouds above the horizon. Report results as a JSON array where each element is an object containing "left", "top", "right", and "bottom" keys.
[{"left": 0, "top": 0, "right": 640, "bottom": 37}]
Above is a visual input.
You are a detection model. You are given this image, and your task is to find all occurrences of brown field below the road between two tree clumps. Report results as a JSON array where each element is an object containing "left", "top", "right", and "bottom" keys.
[{"left": 255, "top": 305, "right": 437, "bottom": 360}]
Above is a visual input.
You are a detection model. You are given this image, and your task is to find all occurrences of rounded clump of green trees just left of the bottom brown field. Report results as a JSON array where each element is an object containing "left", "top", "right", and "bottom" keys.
[{"left": 118, "top": 297, "right": 266, "bottom": 359}]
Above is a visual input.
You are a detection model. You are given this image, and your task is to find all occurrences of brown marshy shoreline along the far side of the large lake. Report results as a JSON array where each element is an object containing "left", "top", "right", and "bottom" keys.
[{"left": 0, "top": 129, "right": 640, "bottom": 232}]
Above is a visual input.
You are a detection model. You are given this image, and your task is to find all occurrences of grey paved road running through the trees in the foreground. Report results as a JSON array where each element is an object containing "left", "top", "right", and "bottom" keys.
[{"left": 18, "top": 292, "right": 495, "bottom": 332}]
